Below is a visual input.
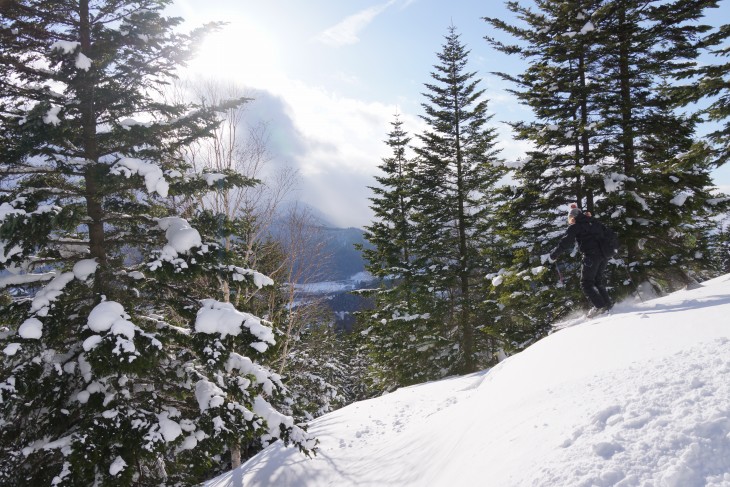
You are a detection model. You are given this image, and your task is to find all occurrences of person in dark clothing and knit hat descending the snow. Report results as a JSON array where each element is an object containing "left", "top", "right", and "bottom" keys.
[{"left": 541, "top": 203, "right": 616, "bottom": 317}]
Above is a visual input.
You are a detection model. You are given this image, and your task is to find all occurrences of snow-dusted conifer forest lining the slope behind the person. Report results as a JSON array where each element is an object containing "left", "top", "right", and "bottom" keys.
[{"left": 0, "top": 0, "right": 730, "bottom": 486}]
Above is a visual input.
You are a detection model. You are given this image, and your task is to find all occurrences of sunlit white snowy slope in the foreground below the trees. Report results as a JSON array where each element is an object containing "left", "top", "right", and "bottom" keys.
[{"left": 206, "top": 275, "right": 730, "bottom": 487}]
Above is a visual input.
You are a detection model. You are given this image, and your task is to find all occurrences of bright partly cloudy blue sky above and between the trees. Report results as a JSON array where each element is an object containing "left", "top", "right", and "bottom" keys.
[{"left": 170, "top": 0, "right": 730, "bottom": 227}]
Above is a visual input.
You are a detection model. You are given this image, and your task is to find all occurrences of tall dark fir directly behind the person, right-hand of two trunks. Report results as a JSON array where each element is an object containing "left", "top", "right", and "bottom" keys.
[{"left": 596, "top": 0, "right": 721, "bottom": 291}]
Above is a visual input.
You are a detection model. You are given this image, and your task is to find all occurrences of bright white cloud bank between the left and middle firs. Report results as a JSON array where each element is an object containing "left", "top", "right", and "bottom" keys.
[{"left": 181, "top": 0, "right": 524, "bottom": 227}]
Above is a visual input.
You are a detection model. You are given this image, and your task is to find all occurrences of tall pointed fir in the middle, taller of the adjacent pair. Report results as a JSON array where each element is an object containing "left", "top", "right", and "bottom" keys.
[{"left": 406, "top": 26, "right": 503, "bottom": 373}]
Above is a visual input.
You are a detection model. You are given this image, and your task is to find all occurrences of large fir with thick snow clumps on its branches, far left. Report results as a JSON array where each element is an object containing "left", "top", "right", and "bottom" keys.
[{"left": 0, "top": 0, "right": 314, "bottom": 485}]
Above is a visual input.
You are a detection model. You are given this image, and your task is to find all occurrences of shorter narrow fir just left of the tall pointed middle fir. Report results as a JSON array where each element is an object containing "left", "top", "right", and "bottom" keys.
[{"left": 359, "top": 116, "right": 448, "bottom": 391}]
